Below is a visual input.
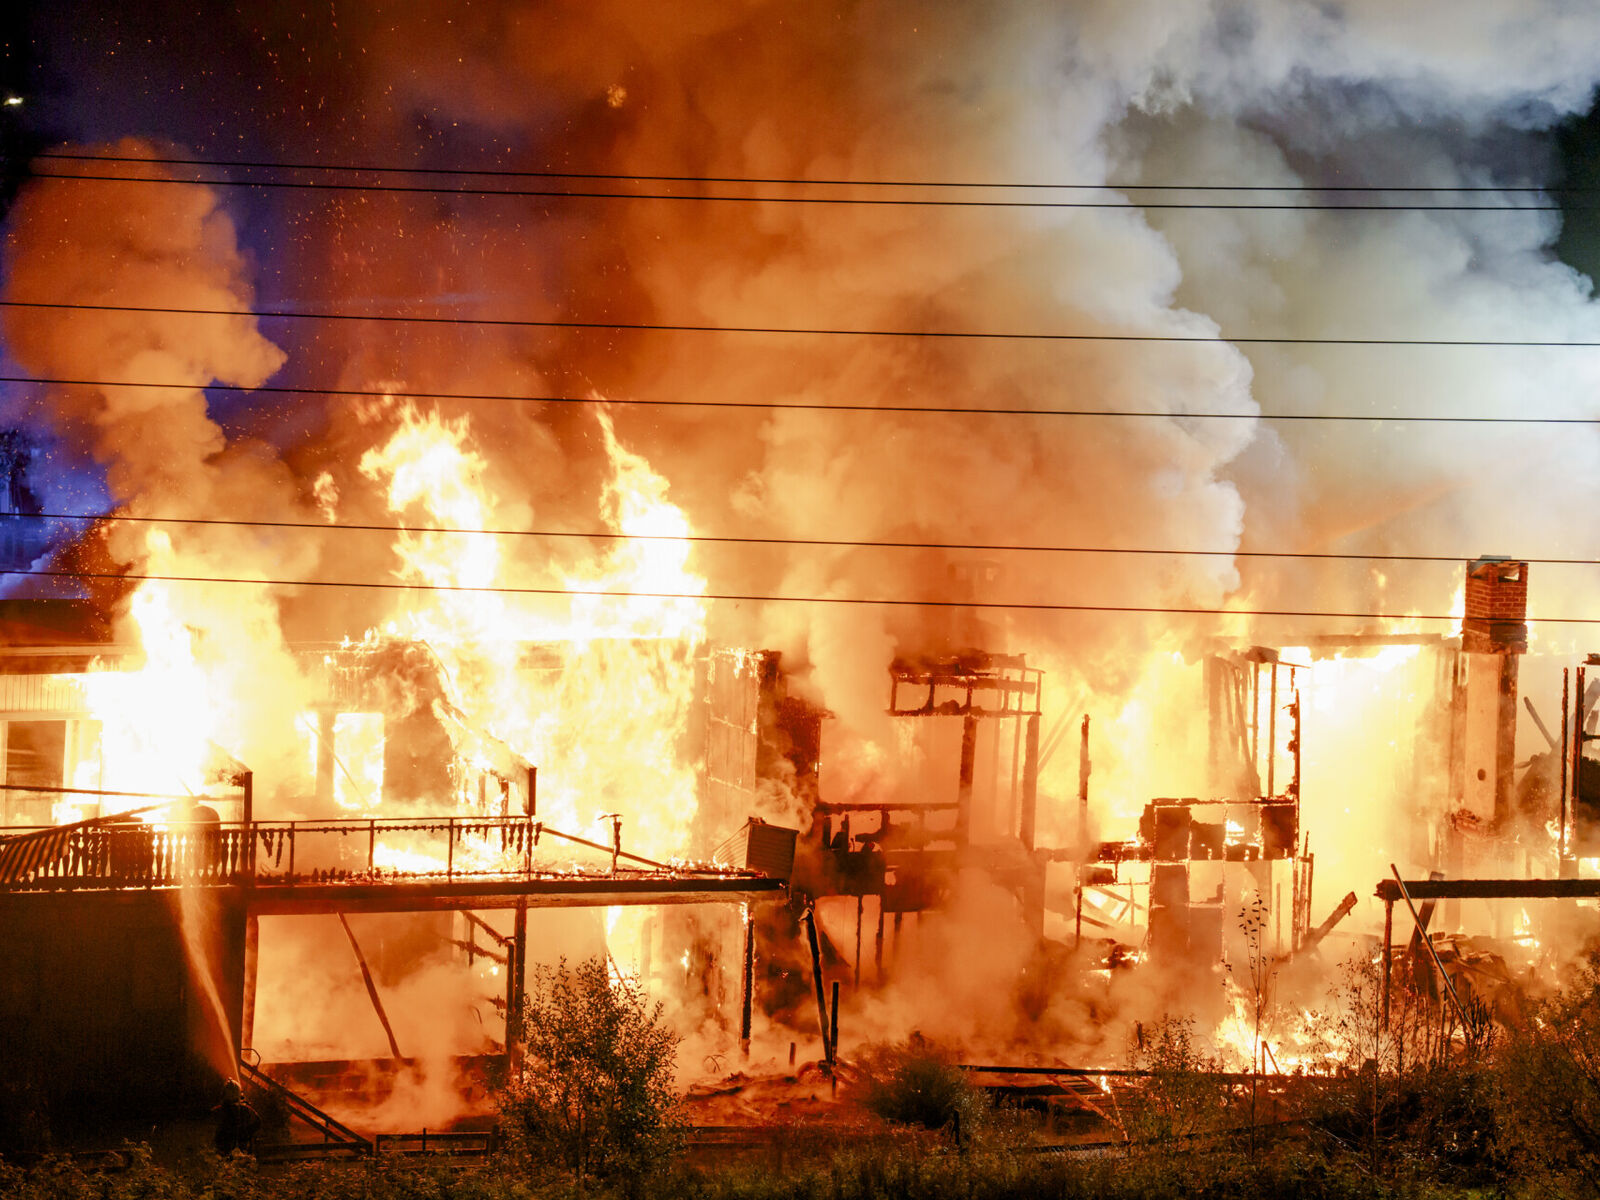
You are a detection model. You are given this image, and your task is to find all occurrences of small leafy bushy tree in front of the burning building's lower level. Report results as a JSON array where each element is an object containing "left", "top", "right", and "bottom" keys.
[{"left": 499, "top": 958, "right": 682, "bottom": 1181}]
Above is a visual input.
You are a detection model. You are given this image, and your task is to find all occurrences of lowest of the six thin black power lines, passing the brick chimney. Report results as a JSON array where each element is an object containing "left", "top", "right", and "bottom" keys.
[{"left": 3, "top": 570, "right": 1574, "bottom": 626}]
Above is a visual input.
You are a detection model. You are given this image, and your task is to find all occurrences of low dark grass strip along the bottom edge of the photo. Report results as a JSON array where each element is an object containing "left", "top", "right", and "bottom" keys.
[{"left": 0, "top": 1126, "right": 1562, "bottom": 1200}]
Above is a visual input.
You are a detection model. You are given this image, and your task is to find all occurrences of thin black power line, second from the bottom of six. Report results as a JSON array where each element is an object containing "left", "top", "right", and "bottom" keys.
[{"left": 18, "top": 512, "right": 1600, "bottom": 566}]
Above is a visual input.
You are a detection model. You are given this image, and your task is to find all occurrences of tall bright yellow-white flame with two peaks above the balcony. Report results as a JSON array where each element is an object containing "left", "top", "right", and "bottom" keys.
[{"left": 360, "top": 408, "right": 706, "bottom": 856}]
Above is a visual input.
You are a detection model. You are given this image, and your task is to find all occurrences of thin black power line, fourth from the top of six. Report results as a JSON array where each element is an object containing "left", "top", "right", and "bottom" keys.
[{"left": 0, "top": 374, "right": 1600, "bottom": 426}]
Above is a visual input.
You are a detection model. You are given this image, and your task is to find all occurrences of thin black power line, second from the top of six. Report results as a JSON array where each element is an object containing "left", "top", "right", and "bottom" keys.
[{"left": 29, "top": 171, "right": 1589, "bottom": 213}]
